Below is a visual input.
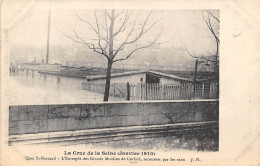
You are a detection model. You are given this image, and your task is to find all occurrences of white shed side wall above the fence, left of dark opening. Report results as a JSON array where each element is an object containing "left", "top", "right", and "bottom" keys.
[{"left": 90, "top": 73, "right": 146, "bottom": 84}]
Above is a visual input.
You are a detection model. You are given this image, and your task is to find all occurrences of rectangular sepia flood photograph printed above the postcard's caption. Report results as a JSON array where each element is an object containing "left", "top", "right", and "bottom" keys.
[{"left": 8, "top": 8, "right": 220, "bottom": 151}]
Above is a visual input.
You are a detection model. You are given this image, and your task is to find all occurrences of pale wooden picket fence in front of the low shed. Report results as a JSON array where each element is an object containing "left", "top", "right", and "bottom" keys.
[{"left": 83, "top": 82, "right": 218, "bottom": 100}]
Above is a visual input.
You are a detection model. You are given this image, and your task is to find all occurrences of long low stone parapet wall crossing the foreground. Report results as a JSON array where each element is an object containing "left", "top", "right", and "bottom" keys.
[{"left": 9, "top": 100, "right": 219, "bottom": 135}]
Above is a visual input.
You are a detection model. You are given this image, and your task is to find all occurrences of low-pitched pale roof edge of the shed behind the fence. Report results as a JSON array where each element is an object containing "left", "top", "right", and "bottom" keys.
[{"left": 86, "top": 71, "right": 193, "bottom": 82}]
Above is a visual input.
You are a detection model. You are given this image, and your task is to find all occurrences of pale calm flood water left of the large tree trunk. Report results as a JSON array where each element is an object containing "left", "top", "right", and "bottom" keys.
[{"left": 8, "top": 71, "right": 119, "bottom": 105}]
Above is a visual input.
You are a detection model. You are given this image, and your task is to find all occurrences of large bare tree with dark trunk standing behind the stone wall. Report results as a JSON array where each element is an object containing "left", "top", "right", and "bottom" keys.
[{"left": 66, "top": 10, "right": 161, "bottom": 101}]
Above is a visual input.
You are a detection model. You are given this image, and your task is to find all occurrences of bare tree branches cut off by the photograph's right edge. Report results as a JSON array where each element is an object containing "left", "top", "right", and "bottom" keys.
[{"left": 186, "top": 10, "right": 220, "bottom": 70}]
